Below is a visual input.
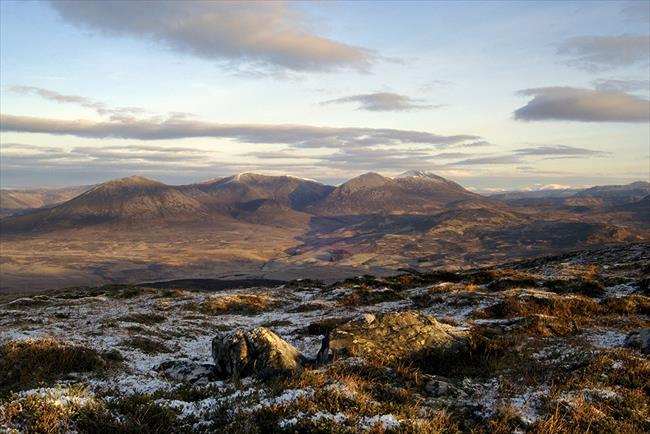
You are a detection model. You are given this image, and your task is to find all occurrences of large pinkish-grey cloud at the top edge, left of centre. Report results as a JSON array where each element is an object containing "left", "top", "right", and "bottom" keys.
[{"left": 50, "top": 1, "right": 377, "bottom": 71}]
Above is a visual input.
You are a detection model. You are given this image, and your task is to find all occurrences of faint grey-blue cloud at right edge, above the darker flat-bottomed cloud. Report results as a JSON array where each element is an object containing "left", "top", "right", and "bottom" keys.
[{"left": 557, "top": 35, "right": 650, "bottom": 72}]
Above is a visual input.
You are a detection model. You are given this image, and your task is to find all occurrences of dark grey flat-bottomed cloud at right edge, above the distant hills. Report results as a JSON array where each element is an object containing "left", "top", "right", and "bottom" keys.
[{"left": 514, "top": 87, "right": 650, "bottom": 122}]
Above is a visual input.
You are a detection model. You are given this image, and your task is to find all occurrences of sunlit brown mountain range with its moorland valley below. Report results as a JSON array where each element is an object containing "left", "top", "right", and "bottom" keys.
[{"left": 0, "top": 172, "right": 650, "bottom": 290}]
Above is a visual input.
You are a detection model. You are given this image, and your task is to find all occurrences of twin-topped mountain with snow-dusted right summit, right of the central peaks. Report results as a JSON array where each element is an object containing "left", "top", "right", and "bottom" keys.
[{"left": 308, "top": 172, "right": 488, "bottom": 216}]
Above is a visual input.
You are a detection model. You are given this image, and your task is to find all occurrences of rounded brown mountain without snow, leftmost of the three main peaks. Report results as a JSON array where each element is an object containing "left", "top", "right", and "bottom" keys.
[{"left": 2, "top": 176, "right": 208, "bottom": 232}]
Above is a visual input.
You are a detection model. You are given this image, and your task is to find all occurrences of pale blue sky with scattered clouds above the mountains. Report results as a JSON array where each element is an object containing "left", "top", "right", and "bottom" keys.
[{"left": 0, "top": 0, "right": 650, "bottom": 192}]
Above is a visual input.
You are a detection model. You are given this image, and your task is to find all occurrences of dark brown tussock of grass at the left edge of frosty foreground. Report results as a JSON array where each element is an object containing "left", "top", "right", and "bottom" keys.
[{"left": 0, "top": 338, "right": 106, "bottom": 395}]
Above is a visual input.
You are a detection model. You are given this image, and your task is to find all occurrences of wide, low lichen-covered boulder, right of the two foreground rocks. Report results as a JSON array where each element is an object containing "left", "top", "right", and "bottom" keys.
[{"left": 317, "top": 311, "right": 467, "bottom": 362}]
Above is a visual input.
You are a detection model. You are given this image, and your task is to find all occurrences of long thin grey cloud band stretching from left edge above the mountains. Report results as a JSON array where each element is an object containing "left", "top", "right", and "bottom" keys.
[{"left": 0, "top": 114, "right": 480, "bottom": 148}]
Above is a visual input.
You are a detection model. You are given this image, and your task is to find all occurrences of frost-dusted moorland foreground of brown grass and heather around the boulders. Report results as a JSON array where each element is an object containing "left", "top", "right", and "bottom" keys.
[{"left": 0, "top": 245, "right": 650, "bottom": 433}]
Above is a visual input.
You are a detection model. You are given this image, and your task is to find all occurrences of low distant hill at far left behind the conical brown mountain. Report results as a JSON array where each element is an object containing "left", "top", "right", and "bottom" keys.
[{"left": 0, "top": 186, "right": 91, "bottom": 215}]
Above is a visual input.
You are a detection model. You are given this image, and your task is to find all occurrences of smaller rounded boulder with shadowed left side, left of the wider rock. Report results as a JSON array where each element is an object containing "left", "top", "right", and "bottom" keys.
[{"left": 212, "top": 327, "right": 304, "bottom": 379}]
